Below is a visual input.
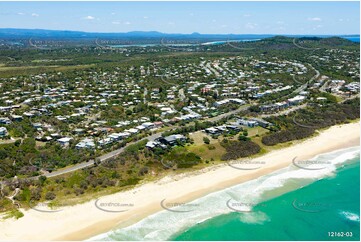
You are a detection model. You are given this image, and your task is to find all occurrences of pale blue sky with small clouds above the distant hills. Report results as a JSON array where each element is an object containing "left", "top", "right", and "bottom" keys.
[{"left": 0, "top": 1, "right": 360, "bottom": 35}]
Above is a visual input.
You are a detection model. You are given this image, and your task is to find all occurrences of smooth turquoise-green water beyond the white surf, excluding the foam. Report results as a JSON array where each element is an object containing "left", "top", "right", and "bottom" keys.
[{"left": 172, "top": 158, "right": 360, "bottom": 241}]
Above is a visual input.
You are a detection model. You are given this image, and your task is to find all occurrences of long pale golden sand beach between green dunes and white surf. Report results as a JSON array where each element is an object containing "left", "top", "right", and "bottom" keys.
[{"left": 0, "top": 122, "right": 360, "bottom": 241}]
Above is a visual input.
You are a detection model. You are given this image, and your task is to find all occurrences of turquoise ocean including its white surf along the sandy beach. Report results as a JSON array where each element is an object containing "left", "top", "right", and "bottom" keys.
[{"left": 90, "top": 147, "right": 360, "bottom": 241}]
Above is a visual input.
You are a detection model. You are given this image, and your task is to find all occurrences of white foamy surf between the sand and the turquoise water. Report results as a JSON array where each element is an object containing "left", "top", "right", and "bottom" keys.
[{"left": 89, "top": 146, "right": 360, "bottom": 241}]
